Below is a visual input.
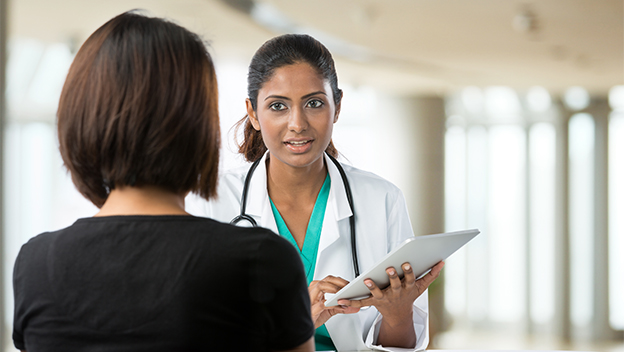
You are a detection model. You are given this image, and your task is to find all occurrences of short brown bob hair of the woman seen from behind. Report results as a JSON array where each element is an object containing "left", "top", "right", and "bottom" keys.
[{"left": 57, "top": 11, "right": 220, "bottom": 207}]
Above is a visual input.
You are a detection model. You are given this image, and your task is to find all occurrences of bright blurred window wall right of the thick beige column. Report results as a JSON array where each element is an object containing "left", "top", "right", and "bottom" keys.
[{"left": 442, "top": 86, "right": 624, "bottom": 348}]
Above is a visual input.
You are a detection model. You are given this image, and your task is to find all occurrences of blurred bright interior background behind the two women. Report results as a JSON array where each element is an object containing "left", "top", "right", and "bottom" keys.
[{"left": 0, "top": 0, "right": 624, "bottom": 351}]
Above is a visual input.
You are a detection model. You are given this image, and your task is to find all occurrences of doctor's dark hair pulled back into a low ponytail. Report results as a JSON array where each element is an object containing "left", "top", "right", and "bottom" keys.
[{"left": 236, "top": 34, "right": 342, "bottom": 161}]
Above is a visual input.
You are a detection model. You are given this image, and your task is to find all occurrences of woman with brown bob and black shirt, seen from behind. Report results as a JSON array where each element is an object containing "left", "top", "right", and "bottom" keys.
[{"left": 13, "top": 12, "right": 314, "bottom": 352}]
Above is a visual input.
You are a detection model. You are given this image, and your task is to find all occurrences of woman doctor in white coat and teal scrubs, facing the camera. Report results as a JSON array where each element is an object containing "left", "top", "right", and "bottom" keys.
[{"left": 201, "top": 35, "right": 443, "bottom": 351}]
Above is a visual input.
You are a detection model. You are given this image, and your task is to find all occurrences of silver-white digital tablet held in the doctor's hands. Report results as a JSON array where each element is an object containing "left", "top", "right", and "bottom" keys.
[{"left": 325, "top": 229, "right": 479, "bottom": 307}]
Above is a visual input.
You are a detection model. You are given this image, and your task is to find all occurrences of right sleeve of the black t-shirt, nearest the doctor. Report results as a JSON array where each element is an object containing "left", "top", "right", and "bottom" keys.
[{"left": 250, "top": 233, "right": 314, "bottom": 350}]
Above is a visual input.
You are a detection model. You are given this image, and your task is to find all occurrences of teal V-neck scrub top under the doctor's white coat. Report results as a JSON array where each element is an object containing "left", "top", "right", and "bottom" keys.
[{"left": 269, "top": 174, "right": 336, "bottom": 351}]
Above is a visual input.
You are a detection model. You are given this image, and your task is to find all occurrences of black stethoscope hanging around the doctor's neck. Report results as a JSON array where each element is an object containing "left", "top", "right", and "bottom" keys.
[{"left": 230, "top": 154, "right": 360, "bottom": 277}]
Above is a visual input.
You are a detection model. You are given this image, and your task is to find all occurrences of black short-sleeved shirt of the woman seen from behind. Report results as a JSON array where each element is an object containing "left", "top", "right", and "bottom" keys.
[{"left": 13, "top": 215, "right": 314, "bottom": 352}]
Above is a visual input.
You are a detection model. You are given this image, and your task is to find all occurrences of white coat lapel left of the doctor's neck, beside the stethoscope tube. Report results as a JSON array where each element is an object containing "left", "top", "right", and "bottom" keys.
[{"left": 247, "top": 153, "right": 278, "bottom": 233}]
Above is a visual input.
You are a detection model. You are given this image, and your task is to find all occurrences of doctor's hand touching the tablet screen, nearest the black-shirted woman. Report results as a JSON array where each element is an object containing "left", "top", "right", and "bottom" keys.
[{"left": 308, "top": 275, "right": 360, "bottom": 329}]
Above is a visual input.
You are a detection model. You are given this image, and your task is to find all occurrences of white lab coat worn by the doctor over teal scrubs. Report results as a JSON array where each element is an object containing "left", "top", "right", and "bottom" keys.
[{"left": 187, "top": 155, "right": 429, "bottom": 351}]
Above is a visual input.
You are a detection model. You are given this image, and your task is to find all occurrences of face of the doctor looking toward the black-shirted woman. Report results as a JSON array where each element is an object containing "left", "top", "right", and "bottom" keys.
[{"left": 247, "top": 63, "right": 340, "bottom": 172}]
